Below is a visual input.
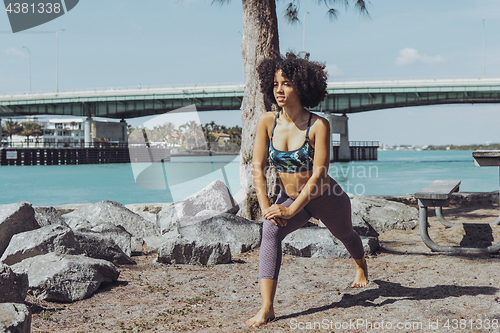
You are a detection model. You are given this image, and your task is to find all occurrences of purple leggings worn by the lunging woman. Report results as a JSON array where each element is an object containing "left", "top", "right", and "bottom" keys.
[{"left": 259, "top": 178, "right": 364, "bottom": 280}]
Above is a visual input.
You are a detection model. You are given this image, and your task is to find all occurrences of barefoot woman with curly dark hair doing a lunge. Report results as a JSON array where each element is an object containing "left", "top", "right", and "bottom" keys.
[{"left": 246, "top": 53, "right": 368, "bottom": 327}]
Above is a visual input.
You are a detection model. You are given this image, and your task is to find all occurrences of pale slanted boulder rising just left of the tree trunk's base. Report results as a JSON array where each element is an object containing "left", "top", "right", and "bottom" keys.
[{"left": 158, "top": 180, "right": 239, "bottom": 233}]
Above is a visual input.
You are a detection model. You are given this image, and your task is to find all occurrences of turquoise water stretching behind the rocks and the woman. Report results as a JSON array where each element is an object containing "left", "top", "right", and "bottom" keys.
[{"left": 0, "top": 151, "right": 499, "bottom": 206}]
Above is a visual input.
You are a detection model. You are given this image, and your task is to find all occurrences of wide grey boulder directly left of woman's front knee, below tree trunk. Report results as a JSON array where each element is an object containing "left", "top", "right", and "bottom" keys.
[{"left": 179, "top": 213, "right": 262, "bottom": 254}]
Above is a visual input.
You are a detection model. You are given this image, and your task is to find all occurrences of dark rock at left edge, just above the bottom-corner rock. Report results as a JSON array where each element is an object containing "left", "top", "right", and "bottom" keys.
[{"left": 0, "top": 263, "right": 28, "bottom": 302}]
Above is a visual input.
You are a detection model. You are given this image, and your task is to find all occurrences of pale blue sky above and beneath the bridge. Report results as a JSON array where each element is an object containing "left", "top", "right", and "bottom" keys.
[{"left": 0, "top": 0, "right": 500, "bottom": 145}]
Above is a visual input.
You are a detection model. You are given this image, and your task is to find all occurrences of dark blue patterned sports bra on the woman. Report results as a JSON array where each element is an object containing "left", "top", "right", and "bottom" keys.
[{"left": 269, "top": 112, "right": 314, "bottom": 172}]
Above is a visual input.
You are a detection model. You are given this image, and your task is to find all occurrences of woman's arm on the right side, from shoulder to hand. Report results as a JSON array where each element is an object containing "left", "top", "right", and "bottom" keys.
[{"left": 264, "top": 117, "right": 331, "bottom": 219}]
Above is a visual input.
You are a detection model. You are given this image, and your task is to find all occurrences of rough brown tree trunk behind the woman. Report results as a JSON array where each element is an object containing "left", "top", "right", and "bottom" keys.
[{"left": 238, "top": 0, "right": 279, "bottom": 220}]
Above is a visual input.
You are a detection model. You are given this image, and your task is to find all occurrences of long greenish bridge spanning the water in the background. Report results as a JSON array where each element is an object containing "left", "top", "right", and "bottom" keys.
[{"left": 0, "top": 79, "right": 500, "bottom": 160}]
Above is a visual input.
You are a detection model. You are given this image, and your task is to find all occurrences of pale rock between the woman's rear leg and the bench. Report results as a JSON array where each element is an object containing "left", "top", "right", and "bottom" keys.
[{"left": 351, "top": 195, "right": 418, "bottom": 232}]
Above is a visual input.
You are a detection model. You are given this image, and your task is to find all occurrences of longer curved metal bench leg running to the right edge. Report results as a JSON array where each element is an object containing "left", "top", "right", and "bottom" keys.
[{"left": 418, "top": 200, "right": 500, "bottom": 253}]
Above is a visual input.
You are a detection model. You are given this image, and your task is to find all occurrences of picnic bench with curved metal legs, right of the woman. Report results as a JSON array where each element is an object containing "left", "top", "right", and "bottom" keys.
[{"left": 414, "top": 180, "right": 500, "bottom": 253}]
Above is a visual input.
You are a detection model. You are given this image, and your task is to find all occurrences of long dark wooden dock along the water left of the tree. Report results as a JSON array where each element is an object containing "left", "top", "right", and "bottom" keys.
[{"left": 0, "top": 147, "right": 170, "bottom": 165}]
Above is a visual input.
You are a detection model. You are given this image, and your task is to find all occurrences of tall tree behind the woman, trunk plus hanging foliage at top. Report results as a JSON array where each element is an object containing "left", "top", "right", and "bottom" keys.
[{"left": 212, "top": 0, "right": 368, "bottom": 219}]
